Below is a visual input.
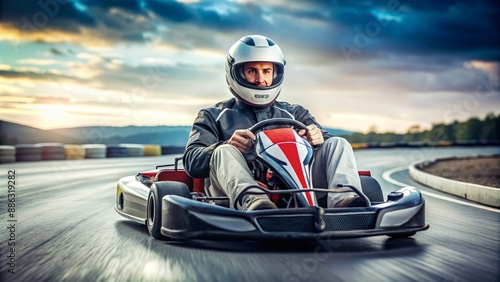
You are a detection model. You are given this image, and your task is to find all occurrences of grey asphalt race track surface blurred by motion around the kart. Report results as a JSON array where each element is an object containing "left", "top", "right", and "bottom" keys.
[{"left": 0, "top": 147, "right": 500, "bottom": 282}]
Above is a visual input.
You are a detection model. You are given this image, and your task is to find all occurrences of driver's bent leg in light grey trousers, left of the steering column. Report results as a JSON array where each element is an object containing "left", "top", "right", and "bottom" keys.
[{"left": 210, "top": 144, "right": 262, "bottom": 209}]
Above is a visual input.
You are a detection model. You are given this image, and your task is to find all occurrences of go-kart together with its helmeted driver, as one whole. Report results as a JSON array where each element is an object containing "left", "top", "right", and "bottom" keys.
[{"left": 115, "top": 35, "right": 429, "bottom": 240}]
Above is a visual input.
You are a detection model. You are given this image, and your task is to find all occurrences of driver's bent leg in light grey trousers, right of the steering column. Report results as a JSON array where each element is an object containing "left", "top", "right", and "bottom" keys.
[{"left": 312, "top": 137, "right": 361, "bottom": 207}]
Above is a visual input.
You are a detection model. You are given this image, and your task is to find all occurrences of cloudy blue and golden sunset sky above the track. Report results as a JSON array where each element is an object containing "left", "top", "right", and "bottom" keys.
[{"left": 0, "top": 0, "right": 500, "bottom": 132}]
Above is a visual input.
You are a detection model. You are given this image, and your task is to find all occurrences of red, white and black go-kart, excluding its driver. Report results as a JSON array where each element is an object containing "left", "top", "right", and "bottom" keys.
[{"left": 115, "top": 119, "right": 429, "bottom": 240}]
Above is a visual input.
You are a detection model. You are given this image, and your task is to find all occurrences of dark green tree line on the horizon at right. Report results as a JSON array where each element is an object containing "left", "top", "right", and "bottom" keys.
[{"left": 343, "top": 113, "right": 500, "bottom": 143}]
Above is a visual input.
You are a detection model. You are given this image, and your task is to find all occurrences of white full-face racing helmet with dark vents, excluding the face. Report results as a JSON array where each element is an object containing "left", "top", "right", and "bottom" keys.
[{"left": 226, "top": 35, "right": 285, "bottom": 107}]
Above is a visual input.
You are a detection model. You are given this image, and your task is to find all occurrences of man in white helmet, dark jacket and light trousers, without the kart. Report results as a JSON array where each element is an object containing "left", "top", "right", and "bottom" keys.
[{"left": 183, "top": 35, "right": 367, "bottom": 211}]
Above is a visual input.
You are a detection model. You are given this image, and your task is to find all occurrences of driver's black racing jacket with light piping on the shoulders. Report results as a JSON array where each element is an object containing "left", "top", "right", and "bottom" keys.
[{"left": 183, "top": 98, "right": 333, "bottom": 178}]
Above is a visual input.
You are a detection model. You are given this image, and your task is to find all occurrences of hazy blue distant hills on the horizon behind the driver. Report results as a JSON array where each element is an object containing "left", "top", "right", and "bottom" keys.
[{"left": 0, "top": 121, "right": 352, "bottom": 146}]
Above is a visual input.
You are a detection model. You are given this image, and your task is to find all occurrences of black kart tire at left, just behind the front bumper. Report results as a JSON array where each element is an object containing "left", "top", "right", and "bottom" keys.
[{"left": 146, "top": 181, "right": 191, "bottom": 240}]
